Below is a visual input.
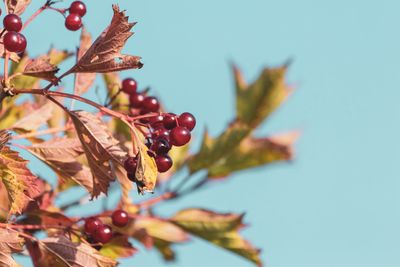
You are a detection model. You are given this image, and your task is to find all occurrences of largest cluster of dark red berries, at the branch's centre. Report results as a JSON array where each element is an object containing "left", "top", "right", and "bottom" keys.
[{"left": 121, "top": 78, "right": 196, "bottom": 178}]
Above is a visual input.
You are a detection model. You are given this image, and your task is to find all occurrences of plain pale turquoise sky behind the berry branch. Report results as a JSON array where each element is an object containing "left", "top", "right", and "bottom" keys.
[{"left": 14, "top": 0, "right": 400, "bottom": 267}]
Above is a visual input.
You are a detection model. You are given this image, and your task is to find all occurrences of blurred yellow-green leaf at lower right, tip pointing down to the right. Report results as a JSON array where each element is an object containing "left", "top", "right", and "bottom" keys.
[{"left": 171, "top": 209, "right": 262, "bottom": 266}]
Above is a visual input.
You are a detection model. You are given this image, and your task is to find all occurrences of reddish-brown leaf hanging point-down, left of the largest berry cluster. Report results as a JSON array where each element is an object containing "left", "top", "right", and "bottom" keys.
[{"left": 68, "top": 111, "right": 127, "bottom": 197}]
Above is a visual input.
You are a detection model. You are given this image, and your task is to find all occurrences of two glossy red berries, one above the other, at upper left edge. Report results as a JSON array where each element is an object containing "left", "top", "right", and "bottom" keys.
[{"left": 3, "top": 14, "right": 27, "bottom": 53}]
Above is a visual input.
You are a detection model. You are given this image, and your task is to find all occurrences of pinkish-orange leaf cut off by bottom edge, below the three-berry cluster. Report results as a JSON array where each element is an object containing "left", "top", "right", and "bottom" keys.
[{"left": 35, "top": 236, "right": 117, "bottom": 267}]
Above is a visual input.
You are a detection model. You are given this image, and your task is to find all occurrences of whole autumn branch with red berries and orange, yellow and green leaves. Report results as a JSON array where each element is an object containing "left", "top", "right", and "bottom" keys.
[{"left": 0, "top": 0, "right": 298, "bottom": 267}]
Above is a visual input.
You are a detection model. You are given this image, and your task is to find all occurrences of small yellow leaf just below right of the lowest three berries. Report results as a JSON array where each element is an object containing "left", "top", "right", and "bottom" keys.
[{"left": 100, "top": 236, "right": 137, "bottom": 260}]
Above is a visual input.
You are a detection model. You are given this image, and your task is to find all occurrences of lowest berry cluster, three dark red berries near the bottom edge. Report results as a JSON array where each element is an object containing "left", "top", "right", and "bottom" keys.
[{"left": 83, "top": 210, "right": 129, "bottom": 244}]
